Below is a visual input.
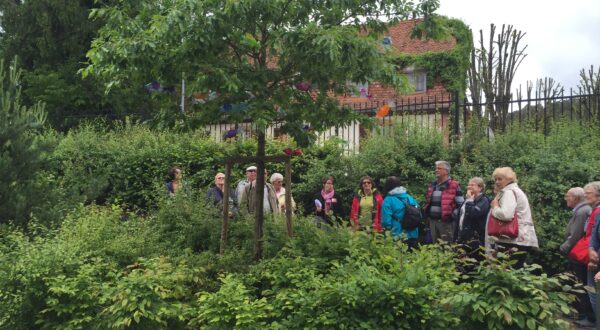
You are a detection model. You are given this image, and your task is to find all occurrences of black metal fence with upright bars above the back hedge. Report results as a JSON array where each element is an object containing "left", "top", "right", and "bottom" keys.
[{"left": 52, "top": 91, "right": 600, "bottom": 153}]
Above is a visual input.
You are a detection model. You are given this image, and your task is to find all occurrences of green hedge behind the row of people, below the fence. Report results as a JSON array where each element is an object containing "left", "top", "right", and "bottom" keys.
[{"left": 34, "top": 119, "right": 600, "bottom": 271}]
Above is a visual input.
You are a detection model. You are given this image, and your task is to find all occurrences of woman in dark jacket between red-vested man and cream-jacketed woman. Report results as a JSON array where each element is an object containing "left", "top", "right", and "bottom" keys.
[{"left": 454, "top": 177, "right": 490, "bottom": 256}]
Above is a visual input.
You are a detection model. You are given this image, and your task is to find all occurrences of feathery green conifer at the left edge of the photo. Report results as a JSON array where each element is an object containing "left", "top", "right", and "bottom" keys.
[{"left": 0, "top": 60, "right": 48, "bottom": 225}]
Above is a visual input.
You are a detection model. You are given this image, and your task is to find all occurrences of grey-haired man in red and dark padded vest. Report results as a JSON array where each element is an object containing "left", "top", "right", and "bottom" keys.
[{"left": 424, "top": 160, "right": 464, "bottom": 243}]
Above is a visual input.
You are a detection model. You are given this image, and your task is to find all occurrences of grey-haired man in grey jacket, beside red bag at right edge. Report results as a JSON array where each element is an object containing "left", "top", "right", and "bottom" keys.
[{"left": 560, "top": 187, "right": 594, "bottom": 320}]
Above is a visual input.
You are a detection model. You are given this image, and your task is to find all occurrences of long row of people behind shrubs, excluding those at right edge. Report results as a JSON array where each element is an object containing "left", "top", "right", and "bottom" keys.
[{"left": 167, "top": 160, "right": 540, "bottom": 267}]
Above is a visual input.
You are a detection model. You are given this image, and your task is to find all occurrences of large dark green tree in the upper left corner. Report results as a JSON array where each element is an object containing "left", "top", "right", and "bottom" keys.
[{"left": 0, "top": 0, "right": 155, "bottom": 129}]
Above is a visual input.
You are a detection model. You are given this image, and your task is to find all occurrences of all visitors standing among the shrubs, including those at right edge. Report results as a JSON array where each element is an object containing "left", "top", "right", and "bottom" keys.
[{"left": 167, "top": 160, "right": 600, "bottom": 325}]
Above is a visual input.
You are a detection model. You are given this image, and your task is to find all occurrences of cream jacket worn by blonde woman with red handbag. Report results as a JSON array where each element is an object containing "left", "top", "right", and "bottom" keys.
[{"left": 486, "top": 183, "right": 538, "bottom": 247}]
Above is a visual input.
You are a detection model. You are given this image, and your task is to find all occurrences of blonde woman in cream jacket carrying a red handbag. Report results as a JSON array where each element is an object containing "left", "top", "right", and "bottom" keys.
[{"left": 490, "top": 167, "right": 538, "bottom": 268}]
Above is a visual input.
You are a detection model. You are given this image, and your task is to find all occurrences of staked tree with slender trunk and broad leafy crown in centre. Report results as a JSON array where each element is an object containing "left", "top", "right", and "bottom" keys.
[{"left": 84, "top": 0, "right": 439, "bottom": 260}]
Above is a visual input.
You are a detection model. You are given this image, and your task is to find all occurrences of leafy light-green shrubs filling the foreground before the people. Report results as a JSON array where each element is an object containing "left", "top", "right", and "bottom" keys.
[{"left": 0, "top": 201, "right": 572, "bottom": 329}]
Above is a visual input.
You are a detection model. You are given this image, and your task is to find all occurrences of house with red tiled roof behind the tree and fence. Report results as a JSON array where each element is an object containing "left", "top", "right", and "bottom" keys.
[{"left": 209, "top": 20, "right": 470, "bottom": 153}]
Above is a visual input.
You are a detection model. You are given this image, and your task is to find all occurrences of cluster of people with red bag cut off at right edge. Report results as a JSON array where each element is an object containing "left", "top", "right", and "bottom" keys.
[{"left": 559, "top": 181, "right": 600, "bottom": 326}]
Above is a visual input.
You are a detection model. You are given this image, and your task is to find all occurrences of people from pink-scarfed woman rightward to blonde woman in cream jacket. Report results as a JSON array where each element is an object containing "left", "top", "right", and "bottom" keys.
[{"left": 338, "top": 161, "right": 538, "bottom": 260}]
